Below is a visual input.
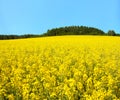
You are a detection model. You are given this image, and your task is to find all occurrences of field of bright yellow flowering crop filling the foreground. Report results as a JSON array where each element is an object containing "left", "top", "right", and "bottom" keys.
[{"left": 0, "top": 36, "right": 120, "bottom": 100}]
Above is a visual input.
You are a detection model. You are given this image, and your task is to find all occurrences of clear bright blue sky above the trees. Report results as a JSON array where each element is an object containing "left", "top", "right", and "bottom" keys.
[{"left": 0, "top": 0, "right": 120, "bottom": 34}]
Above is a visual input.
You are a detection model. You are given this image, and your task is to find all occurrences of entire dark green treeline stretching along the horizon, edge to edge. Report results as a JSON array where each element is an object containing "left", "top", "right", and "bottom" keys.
[{"left": 0, "top": 26, "right": 120, "bottom": 40}]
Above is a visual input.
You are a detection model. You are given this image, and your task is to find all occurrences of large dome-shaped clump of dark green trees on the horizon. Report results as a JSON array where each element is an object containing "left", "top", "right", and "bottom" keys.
[{"left": 44, "top": 26, "right": 105, "bottom": 36}]
